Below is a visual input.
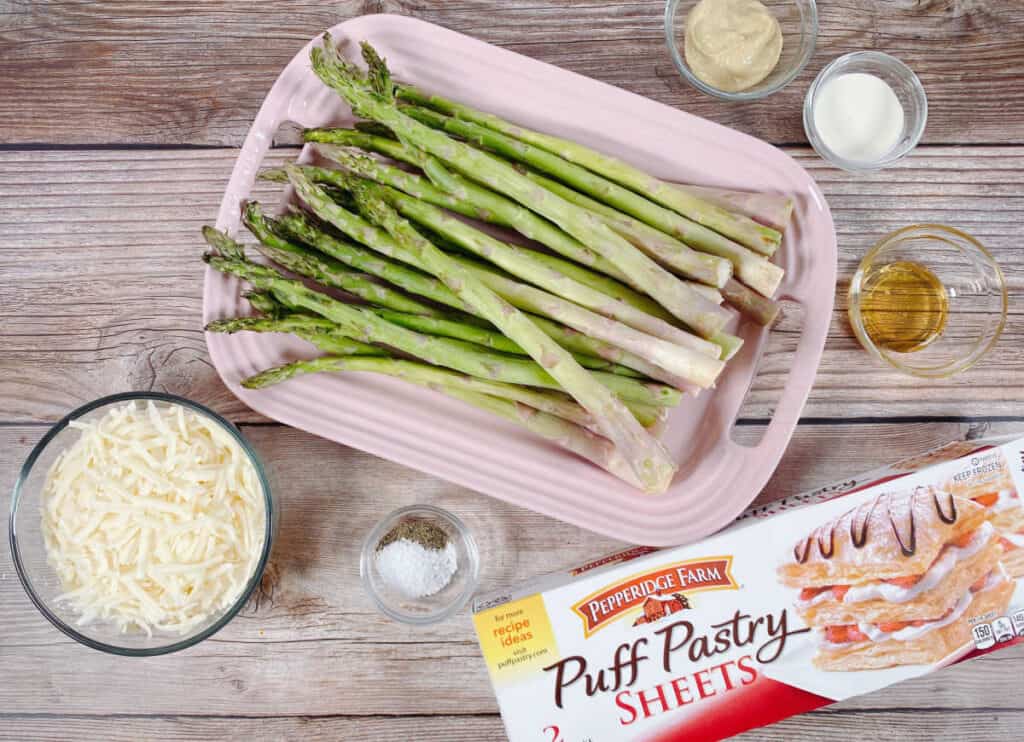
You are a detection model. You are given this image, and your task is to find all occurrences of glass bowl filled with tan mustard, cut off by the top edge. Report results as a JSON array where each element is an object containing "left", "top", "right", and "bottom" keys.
[{"left": 665, "top": 0, "right": 818, "bottom": 100}]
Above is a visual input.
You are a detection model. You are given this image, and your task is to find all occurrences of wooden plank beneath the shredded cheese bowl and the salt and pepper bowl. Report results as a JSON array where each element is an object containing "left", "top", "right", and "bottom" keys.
[{"left": 0, "top": 423, "right": 1024, "bottom": 716}]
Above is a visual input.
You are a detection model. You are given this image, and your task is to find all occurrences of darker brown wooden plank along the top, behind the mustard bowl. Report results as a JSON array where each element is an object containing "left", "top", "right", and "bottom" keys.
[{"left": 0, "top": 0, "right": 1024, "bottom": 145}]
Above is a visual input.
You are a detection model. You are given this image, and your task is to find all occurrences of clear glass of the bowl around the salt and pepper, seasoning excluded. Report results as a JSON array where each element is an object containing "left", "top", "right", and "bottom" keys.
[{"left": 359, "top": 505, "right": 480, "bottom": 625}]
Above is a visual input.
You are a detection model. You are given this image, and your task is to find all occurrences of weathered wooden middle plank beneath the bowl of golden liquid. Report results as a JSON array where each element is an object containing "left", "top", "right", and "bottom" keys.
[{"left": 0, "top": 147, "right": 1024, "bottom": 422}]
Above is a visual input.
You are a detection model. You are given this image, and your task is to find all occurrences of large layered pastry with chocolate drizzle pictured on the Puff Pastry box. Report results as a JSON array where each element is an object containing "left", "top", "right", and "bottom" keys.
[{"left": 778, "top": 486, "right": 1015, "bottom": 671}]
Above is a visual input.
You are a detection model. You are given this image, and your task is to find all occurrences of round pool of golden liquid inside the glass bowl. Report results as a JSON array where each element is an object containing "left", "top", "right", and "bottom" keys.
[{"left": 860, "top": 260, "right": 949, "bottom": 353}]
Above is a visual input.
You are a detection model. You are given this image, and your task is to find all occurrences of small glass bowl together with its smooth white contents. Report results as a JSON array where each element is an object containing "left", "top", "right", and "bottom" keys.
[{"left": 804, "top": 51, "right": 928, "bottom": 173}]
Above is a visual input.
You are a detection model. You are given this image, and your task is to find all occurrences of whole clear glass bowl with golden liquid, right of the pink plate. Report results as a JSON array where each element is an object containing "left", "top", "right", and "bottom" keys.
[{"left": 849, "top": 224, "right": 1008, "bottom": 379}]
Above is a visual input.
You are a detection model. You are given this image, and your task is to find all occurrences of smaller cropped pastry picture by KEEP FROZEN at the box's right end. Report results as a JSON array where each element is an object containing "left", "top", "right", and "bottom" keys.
[{"left": 944, "top": 448, "right": 1024, "bottom": 577}]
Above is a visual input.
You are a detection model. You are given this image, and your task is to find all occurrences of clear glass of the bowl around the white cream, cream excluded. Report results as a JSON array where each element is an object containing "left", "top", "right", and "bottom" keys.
[{"left": 804, "top": 51, "right": 928, "bottom": 173}]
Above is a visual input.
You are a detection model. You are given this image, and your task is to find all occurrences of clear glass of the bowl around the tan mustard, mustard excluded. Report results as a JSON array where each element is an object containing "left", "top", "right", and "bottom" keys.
[{"left": 665, "top": 0, "right": 818, "bottom": 100}]
